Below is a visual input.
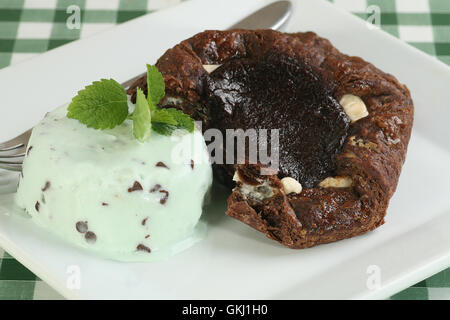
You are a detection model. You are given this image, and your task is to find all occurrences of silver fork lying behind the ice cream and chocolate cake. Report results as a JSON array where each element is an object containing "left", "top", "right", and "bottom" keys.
[{"left": 0, "top": 0, "right": 292, "bottom": 171}]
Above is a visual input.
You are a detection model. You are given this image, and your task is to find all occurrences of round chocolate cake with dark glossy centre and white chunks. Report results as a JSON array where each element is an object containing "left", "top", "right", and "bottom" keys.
[{"left": 128, "top": 30, "right": 414, "bottom": 248}]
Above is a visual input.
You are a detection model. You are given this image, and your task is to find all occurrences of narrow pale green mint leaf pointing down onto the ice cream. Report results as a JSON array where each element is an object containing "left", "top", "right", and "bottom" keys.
[{"left": 131, "top": 88, "right": 152, "bottom": 142}]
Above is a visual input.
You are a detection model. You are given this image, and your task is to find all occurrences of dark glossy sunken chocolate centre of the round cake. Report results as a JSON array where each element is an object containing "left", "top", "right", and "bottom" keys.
[{"left": 205, "top": 55, "right": 350, "bottom": 188}]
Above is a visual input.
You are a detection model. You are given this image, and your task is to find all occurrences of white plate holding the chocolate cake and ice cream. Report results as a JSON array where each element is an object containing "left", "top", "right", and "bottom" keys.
[{"left": 0, "top": 0, "right": 450, "bottom": 299}]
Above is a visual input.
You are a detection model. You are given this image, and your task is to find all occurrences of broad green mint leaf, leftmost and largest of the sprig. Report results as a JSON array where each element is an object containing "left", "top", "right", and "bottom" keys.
[{"left": 67, "top": 79, "right": 128, "bottom": 129}]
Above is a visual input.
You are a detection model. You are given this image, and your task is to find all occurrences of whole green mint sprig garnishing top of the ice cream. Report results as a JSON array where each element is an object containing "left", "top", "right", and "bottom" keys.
[{"left": 67, "top": 65, "right": 194, "bottom": 142}]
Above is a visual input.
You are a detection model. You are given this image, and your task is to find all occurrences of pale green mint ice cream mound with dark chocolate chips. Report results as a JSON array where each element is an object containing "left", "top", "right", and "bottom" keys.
[{"left": 16, "top": 105, "right": 212, "bottom": 261}]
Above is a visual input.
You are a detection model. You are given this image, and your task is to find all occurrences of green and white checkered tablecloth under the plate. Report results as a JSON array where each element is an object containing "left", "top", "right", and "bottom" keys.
[{"left": 0, "top": 0, "right": 450, "bottom": 300}]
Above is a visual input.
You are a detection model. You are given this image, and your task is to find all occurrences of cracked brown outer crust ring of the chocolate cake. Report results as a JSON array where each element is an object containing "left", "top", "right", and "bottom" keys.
[{"left": 128, "top": 30, "right": 414, "bottom": 248}]
